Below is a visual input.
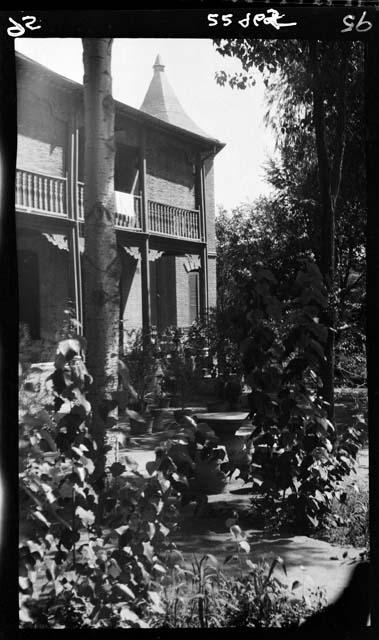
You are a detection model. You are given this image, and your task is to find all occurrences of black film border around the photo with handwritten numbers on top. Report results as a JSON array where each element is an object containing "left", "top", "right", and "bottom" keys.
[{"left": 0, "top": 0, "right": 379, "bottom": 638}]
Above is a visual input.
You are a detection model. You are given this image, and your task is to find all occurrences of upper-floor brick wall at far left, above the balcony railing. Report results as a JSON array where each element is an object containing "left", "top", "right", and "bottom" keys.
[{"left": 17, "top": 84, "right": 68, "bottom": 176}]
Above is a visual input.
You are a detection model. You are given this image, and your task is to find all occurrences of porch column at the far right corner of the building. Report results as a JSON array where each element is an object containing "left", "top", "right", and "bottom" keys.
[{"left": 195, "top": 154, "right": 208, "bottom": 320}]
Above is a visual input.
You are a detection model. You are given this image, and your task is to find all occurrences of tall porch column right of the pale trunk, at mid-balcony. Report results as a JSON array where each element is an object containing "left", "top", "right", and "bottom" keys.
[{"left": 140, "top": 130, "right": 151, "bottom": 342}]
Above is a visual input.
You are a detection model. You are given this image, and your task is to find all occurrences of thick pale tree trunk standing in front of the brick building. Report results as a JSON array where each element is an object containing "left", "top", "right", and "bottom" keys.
[{"left": 83, "top": 38, "right": 120, "bottom": 488}]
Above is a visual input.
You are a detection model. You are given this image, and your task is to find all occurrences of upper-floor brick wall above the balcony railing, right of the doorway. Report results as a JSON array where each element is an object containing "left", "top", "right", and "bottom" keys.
[{"left": 146, "top": 133, "right": 195, "bottom": 209}]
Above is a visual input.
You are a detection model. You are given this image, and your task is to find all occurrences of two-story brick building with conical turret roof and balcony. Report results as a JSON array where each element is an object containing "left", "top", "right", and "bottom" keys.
[{"left": 16, "top": 54, "right": 223, "bottom": 356}]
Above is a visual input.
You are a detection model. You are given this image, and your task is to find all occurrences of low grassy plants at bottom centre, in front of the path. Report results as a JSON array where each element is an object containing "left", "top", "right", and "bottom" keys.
[{"left": 147, "top": 525, "right": 324, "bottom": 628}]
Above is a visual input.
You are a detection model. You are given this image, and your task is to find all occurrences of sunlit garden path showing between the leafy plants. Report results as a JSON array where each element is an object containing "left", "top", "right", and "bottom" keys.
[{"left": 120, "top": 428, "right": 368, "bottom": 602}]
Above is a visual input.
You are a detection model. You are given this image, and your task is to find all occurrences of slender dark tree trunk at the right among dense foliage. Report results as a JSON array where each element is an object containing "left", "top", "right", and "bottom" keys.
[{"left": 309, "top": 41, "right": 336, "bottom": 422}]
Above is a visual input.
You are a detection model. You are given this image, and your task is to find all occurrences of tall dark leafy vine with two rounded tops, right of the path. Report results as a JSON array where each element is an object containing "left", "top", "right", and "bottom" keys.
[{"left": 220, "top": 261, "right": 366, "bottom": 532}]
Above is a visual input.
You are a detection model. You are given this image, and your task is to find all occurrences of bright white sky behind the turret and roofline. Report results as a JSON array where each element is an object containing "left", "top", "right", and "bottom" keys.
[{"left": 15, "top": 37, "right": 274, "bottom": 210}]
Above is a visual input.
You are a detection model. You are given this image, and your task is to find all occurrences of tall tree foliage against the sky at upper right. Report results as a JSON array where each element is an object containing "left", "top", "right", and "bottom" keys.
[{"left": 215, "top": 39, "right": 366, "bottom": 392}]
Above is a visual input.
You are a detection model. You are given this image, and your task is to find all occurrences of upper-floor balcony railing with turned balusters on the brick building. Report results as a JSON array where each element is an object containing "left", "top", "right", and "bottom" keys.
[{"left": 16, "top": 169, "right": 202, "bottom": 241}]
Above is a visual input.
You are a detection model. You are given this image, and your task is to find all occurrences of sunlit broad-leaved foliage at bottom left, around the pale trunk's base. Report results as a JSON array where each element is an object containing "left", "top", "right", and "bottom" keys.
[{"left": 19, "top": 339, "right": 181, "bottom": 628}]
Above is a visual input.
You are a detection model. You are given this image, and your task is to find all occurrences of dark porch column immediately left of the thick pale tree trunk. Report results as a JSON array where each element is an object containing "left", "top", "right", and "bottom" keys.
[{"left": 66, "top": 114, "right": 83, "bottom": 335}]
